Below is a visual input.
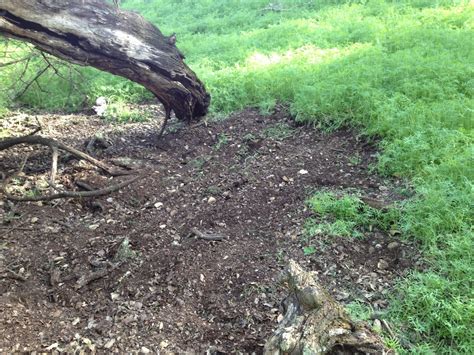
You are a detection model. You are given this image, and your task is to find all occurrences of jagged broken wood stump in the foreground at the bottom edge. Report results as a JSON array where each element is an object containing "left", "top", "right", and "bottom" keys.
[{"left": 265, "top": 260, "right": 387, "bottom": 354}]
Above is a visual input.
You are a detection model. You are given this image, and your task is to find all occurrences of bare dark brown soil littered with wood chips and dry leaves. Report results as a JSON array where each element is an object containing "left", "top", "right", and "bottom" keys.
[{"left": 0, "top": 108, "right": 418, "bottom": 353}]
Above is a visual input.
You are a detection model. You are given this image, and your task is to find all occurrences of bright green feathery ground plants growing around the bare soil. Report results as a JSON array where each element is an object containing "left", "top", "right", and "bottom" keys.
[{"left": 0, "top": 0, "right": 474, "bottom": 354}]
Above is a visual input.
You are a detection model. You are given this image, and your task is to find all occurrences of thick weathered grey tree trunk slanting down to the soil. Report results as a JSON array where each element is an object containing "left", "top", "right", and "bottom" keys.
[{"left": 0, "top": 0, "right": 210, "bottom": 120}]
